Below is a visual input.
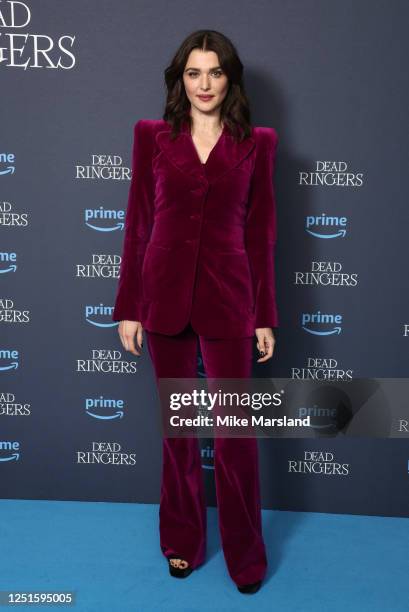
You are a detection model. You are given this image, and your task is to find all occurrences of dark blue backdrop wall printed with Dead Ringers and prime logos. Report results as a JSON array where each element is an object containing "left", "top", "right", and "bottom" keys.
[{"left": 0, "top": 0, "right": 409, "bottom": 516}]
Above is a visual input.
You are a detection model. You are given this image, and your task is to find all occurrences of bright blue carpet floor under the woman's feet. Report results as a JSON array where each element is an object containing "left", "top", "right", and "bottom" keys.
[{"left": 0, "top": 500, "right": 409, "bottom": 612}]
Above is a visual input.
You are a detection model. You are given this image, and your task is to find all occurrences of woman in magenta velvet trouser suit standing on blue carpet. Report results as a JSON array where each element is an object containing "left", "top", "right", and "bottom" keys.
[{"left": 112, "top": 30, "right": 278, "bottom": 593}]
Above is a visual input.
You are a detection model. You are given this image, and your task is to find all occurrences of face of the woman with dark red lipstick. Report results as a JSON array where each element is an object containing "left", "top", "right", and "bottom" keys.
[{"left": 183, "top": 49, "right": 229, "bottom": 113}]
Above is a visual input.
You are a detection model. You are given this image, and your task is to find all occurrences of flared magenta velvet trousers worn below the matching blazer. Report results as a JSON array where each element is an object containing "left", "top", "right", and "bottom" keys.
[{"left": 145, "top": 323, "right": 267, "bottom": 586}]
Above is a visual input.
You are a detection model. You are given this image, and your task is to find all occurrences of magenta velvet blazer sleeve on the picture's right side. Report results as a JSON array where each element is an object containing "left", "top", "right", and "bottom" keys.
[{"left": 245, "top": 128, "right": 279, "bottom": 328}]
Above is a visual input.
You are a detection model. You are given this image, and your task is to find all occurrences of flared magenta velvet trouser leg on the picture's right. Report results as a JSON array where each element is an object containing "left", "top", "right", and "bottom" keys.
[{"left": 200, "top": 337, "right": 267, "bottom": 586}]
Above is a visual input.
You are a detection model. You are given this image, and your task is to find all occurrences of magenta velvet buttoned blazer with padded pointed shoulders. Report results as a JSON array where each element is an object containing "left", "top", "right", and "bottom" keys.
[{"left": 112, "top": 119, "right": 278, "bottom": 338}]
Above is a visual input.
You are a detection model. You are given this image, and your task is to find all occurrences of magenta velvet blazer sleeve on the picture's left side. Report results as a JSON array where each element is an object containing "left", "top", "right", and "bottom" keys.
[{"left": 112, "top": 119, "right": 154, "bottom": 321}]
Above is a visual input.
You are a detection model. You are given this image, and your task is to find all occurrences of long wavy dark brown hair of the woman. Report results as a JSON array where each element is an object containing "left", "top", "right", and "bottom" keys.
[{"left": 162, "top": 30, "right": 251, "bottom": 141}]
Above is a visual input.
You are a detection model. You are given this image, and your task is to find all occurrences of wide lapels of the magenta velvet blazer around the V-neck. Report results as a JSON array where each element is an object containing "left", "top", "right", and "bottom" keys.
[{"left": 156, "top": 122, "right": 255, "bottom": 183}]
